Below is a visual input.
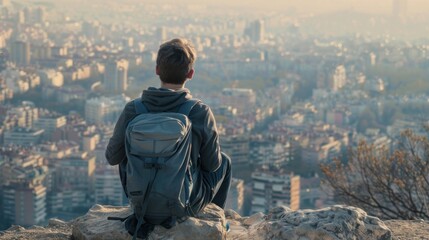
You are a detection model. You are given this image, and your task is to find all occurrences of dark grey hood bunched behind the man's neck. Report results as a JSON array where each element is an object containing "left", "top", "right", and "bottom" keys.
[{"left": 142, "top": 87, "right": 192, "bottom": 112}]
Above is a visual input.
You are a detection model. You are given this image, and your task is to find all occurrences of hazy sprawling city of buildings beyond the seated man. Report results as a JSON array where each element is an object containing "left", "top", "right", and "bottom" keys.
[{"left": 0, "top": 0, "right": 429, "bottom": 230}]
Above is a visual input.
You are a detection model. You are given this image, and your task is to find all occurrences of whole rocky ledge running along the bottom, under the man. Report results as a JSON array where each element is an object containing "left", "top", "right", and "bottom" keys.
[{"left": 0, "top": 205, "right": 429, "bottom": 240}]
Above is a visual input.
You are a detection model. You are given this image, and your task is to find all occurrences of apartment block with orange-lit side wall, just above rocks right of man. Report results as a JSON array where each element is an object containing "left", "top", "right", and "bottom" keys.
[{"left": 251, "top": 168, "right": 300, "bottom": 214}]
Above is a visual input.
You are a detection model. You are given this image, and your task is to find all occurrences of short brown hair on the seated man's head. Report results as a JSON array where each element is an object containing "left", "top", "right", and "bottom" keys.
[{"left": 156, "top": 38, "right": 197, "bottom": 84}]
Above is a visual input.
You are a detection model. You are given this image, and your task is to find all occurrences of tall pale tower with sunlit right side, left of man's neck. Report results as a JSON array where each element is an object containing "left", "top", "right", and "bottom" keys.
[{"left": 104, "top": 59, "right": 128, "bottom": 93}]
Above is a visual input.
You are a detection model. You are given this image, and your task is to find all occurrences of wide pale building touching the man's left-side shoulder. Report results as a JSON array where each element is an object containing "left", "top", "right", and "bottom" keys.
[{"left": 85, "top": 95, "right": 130, "bottom": 124}]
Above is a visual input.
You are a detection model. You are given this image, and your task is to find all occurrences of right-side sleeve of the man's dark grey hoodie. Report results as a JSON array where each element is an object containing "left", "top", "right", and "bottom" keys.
[{"left": 200, "top": 107, "right": 222, "bottom": 172}]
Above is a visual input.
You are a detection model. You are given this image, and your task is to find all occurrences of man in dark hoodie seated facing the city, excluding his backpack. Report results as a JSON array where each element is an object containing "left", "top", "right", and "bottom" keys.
[{"left": 106, "top": 39, "right": 231, "bottom": 214}]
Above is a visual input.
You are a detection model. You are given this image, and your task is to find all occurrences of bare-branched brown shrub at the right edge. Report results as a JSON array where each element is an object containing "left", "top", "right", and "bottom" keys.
[{"left": 321, "top": 130, "right": 429, "bottom": 220}]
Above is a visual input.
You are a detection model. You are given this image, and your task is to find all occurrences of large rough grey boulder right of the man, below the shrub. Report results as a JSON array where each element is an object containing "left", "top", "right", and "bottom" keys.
[{"left": 249, "top": 205, "right": 392, "bottom": 240}]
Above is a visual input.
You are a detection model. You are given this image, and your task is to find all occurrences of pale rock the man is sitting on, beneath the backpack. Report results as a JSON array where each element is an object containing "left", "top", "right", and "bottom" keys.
[{"left": 72, "top": 204, "right": 226, "bottom": 240}]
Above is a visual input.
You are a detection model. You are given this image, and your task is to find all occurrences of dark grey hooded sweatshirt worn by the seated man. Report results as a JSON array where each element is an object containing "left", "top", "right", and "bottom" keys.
[{"left": 106, "top": 87, "right": 222, "bottom": 198}]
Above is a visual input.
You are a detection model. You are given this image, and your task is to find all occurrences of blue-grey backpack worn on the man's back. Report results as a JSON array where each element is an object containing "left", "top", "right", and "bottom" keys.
[{"left": 109, "top": 98, "right": 199, "bottom": 239}]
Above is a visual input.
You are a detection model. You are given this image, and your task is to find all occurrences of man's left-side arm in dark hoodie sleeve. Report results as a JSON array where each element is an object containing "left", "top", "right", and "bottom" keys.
[{"left": 105, "top": 101, "right": 136, "bottom": 165}]
